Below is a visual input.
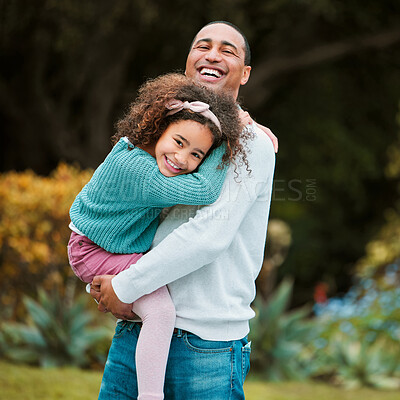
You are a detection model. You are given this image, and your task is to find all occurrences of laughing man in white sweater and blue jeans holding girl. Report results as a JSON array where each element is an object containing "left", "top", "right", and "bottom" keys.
[{"left": 91, "top": 22, "right": 275, "bottom": 400}]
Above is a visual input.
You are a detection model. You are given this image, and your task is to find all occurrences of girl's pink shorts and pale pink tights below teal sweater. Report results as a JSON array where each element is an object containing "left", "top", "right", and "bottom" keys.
[{"left": 68, "top": 232, "right": 175, "bottom": 400}]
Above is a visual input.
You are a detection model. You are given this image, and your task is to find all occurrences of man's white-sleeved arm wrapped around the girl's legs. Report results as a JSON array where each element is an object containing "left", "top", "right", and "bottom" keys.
[{"left": 92, "top": 128, "right": 275, "bottom": 313}]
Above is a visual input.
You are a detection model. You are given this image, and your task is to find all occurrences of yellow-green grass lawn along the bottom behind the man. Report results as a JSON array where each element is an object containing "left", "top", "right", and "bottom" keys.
[{"left": 0, "top": 362, "right": 400, "bottom": 400}]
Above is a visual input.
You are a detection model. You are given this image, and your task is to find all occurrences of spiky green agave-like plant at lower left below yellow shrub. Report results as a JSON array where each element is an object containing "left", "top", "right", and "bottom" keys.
[{"left": 1, "top": 290, "right": 113, "bottom": 367}]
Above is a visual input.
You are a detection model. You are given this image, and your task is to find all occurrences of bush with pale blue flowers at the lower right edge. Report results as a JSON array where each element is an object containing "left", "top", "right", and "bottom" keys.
[{"left": 314, "top": 276, "right": 400, "bottom": 389}]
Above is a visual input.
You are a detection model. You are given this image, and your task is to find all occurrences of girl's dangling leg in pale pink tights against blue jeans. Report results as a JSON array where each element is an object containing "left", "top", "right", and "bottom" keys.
[{"left": 132, "top": 286, "right": 175, "bottom": 400}]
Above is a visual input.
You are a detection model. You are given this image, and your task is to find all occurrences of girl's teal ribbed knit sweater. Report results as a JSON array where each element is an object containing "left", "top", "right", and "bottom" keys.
[{"left": 70, "top": 138, "right": 227, "bottom": 254}]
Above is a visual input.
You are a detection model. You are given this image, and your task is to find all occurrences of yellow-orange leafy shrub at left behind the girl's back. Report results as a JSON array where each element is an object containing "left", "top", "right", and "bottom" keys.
[{"left": 0, "top": 163, "right": 92, "bottom": 317}]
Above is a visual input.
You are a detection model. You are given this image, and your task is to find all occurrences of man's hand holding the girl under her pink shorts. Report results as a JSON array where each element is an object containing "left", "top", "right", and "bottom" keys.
[{"left": 90, "top": 275, "right": 137, "bottom": 319}]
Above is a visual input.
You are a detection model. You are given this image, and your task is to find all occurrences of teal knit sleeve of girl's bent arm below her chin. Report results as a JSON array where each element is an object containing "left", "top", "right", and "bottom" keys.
[{"left": 143, "top": 144, "right": 228, "bottom": 207}]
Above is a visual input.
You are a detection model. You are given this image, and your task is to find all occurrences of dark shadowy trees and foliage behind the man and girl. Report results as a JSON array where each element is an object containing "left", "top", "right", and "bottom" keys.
[{"left": 0, "top": 0, "right": 400, "bottom": 304}]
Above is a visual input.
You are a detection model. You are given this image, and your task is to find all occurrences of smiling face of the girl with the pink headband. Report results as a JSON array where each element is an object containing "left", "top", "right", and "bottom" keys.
[{"left": 155, "top": 120, "right": 214, "bottom": 177}]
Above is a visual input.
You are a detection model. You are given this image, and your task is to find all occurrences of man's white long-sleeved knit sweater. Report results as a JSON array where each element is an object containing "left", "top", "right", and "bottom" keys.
[{"left": 112, "top": 125, "right": 275, "bottom": 340}]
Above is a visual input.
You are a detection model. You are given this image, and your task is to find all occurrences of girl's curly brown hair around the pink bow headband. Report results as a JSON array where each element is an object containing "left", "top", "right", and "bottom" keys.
[{"left": 112, "top": 73, "right": 251, "bottom": 172}]
